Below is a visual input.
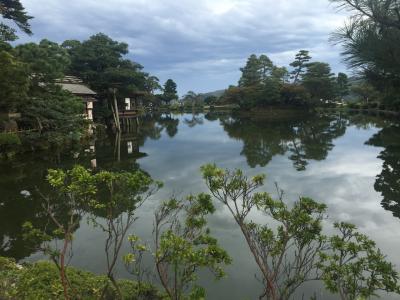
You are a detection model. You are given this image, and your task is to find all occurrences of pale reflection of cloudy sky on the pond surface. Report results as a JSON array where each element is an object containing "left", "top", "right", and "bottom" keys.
[{"left": 22, "top": 116, "right": 400, "bottom": 299}]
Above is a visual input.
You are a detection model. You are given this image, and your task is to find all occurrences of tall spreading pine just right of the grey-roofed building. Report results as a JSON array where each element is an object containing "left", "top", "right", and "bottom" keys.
[{"left": 62, "top": 33, "right": 149, "bottom": 130}]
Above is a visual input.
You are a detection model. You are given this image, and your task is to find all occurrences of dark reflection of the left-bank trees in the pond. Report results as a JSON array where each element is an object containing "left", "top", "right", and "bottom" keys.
[{"left": 0, "top": 115, "right": 177, "bottom": 260}]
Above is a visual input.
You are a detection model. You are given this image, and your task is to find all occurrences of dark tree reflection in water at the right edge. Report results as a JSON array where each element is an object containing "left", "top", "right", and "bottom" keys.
[{"left": 366, "top": 125, "right": 400, "bottom": 218}]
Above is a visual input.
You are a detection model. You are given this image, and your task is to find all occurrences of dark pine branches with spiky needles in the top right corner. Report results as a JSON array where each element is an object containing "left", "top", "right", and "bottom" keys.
[{"left": 331, "top": 0, "right": 400, "bottom": 108}]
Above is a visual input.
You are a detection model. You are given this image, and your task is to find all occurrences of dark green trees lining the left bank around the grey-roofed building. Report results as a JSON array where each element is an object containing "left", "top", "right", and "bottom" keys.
[{"left": 0, "top": 1, "right": 178, "bottom": 155}]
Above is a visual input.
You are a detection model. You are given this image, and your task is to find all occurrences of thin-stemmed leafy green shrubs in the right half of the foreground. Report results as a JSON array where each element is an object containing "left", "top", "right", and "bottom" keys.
[{"left": 201, "top": 164, "right": 400, "bottom": 300}]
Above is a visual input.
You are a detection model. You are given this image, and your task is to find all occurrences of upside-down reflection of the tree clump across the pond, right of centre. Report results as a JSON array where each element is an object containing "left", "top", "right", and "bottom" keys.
[{"left": 222, "top": 115, "right": 347, "bottom": 171}]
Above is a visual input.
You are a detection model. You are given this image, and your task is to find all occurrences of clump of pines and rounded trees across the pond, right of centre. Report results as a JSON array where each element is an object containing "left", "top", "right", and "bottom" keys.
[{"left": 220, "top": 50, "right": 349, "bottom": 109}]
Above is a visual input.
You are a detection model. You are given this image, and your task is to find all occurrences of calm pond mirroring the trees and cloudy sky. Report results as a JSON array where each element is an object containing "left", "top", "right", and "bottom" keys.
[{"left": 0, "top": 112, "right": 400, "bottom": 299}]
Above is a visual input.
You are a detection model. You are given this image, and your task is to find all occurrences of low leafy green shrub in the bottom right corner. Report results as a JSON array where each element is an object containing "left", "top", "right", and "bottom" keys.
[{"left": 319, "top": 223, "right": 400, "bottom": 300}]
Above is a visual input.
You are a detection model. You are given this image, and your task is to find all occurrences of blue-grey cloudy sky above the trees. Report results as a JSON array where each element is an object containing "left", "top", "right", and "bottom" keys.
[{"left": 20, "top": 0, "right": 345, "bottom": 94}]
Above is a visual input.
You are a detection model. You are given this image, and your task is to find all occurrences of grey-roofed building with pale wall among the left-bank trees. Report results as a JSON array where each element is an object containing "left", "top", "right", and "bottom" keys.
[{"left": 57, "top": 76, "right": 96, "bottom": 120}]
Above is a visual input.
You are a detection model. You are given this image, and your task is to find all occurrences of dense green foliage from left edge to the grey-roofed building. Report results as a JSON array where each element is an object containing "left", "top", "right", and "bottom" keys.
[{"left": 0, "top": 40, "right": 86, "bottom": 149}]
